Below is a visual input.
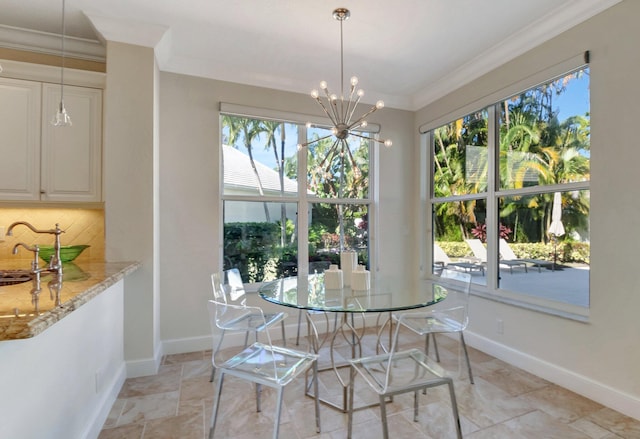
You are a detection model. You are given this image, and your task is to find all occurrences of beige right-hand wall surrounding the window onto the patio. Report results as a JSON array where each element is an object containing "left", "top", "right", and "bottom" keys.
[{"left": 414, "top": 0, "right": 640, "bottom": 419}]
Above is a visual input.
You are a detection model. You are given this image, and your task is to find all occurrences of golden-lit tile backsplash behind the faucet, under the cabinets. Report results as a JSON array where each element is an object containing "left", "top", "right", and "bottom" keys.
[{"left": 0, "top": 207, "right": 104, "bottom": 262}]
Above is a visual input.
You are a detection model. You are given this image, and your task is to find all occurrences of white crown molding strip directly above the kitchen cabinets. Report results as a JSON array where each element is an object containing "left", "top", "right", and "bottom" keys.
[{"left": 0, "top": 25, "right": 106, "bottom": 62}]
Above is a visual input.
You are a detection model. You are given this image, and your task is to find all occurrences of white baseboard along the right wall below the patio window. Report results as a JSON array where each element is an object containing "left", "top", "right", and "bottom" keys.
[{"left": 464, "top": 331, "right": 640, "bottom": 420}]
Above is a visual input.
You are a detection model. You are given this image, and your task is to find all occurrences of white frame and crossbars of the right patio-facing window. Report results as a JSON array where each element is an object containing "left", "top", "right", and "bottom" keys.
[{"left": 419, "top": 57, "right": 591, "bottom": 322}]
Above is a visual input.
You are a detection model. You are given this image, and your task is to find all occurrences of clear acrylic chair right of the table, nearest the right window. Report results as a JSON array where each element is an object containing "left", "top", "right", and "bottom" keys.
[{"left": 394, "top": 268, "right": 473, "bottom": 384}]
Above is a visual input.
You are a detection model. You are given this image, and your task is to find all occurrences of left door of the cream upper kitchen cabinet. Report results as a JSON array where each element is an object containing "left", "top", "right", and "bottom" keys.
[{"left": 0, "top": 78, "right": 41, "bottom": 200}]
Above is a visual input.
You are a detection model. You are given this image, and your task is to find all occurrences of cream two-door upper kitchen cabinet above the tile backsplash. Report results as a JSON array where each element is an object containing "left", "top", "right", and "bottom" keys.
[{"left": 0, "top": 78, "right": 102, "bottom": 202}]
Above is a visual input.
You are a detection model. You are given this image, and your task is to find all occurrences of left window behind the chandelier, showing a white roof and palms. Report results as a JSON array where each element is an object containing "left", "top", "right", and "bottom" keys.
[{"left": 221, "top": 113, "right": 372, "bottom": 283}]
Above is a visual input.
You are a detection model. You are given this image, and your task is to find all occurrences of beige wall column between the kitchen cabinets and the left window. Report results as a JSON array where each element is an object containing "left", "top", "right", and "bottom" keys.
[{"left": 103, "top": 42, "right": 160, "bottom": 376}]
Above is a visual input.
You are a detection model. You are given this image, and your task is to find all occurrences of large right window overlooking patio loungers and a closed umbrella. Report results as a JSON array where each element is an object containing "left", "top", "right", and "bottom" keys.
[{"left": 424, "top": 67, "right": 590, "bottom": 314}]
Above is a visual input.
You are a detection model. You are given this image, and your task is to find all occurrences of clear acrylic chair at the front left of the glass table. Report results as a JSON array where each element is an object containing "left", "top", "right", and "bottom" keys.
[{"left": 207, "top": 300, "right": 320, "bottom": 439}]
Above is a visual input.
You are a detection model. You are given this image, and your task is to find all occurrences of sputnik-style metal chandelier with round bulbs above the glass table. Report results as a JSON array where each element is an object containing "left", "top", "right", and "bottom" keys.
[{"left": 298, "top": 8, "right": 392, "bottom": 157}]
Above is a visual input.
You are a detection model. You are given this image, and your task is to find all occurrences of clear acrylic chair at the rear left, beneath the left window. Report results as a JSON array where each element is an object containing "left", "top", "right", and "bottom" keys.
[{"left": 210, "top": 268, "right": 287, "bottom": 382}]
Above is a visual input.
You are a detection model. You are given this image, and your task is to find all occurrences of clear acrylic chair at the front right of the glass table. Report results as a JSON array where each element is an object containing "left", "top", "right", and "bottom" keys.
[{"left": 347, "top": 314, "right": 462, "bottom": 439}]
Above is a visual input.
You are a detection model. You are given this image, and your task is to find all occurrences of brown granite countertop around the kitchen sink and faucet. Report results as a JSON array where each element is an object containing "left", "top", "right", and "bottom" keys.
[{"left": 0, "top": 260, "right": 140, "bottom": 341}]
